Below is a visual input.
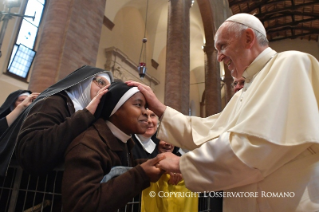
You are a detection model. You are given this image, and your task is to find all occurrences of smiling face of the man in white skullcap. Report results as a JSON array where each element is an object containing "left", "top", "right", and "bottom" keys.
[{"left": 215, "top": 22, "right": 249, "bottom": 78}]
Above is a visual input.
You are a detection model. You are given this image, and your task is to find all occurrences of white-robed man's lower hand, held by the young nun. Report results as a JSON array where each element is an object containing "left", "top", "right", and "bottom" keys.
[{"left": 156, "top": 152, "right": 181, "bottom": 173}]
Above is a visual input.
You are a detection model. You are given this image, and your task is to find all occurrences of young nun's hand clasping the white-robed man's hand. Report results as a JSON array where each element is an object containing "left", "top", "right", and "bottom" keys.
[{"left": 141, "top": 155, "right": 165, "bottom": 182}]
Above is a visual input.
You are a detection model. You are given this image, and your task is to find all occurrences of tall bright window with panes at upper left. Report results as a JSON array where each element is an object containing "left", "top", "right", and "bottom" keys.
[{"left": 7, "top": 0, "right": 45, "bottom": 79}]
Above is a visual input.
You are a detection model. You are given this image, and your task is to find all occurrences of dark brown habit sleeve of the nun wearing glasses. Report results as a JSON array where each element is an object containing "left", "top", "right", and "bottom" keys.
[{"left": 15, "top": 91, "right": 95, "bottom": 176}]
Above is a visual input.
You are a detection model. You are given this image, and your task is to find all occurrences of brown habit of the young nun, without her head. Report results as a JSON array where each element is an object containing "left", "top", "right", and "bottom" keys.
[{"left": 62, "top": 119, "right": 150, "bottom": 212}]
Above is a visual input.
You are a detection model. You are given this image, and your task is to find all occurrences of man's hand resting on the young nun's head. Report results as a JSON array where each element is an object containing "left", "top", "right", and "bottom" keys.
[{"left": 125, "top": 81, "right": 166, "bottom": 117}]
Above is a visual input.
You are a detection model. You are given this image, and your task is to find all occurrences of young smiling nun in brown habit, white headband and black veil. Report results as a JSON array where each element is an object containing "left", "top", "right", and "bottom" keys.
[{"left": 62, "top": 82, "right": 162, "bottom": 212}]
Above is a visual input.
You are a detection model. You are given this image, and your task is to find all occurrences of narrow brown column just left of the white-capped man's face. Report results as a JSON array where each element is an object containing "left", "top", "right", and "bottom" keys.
[{"left": 204, "top": 43, "right": 221, "bottom": 116}]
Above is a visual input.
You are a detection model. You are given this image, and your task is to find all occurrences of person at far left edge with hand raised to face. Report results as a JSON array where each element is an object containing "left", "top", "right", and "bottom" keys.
[{"left": 0, "top": 90, "right": 39, "bottom": 137}]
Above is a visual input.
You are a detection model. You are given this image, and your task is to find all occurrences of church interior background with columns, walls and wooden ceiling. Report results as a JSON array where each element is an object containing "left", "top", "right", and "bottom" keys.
[{"left": 0, "top": 0, "right": 319, "bottom": 211}]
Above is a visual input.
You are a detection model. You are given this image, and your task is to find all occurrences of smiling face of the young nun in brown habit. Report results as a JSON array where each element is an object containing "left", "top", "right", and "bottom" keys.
[{"left": 109, "top": 92, "right": 148, "bottom": 135}]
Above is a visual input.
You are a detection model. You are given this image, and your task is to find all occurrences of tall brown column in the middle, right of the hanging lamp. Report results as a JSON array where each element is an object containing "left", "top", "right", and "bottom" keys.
[{"left": 164, "top": 0, "right": 191, "bottom": 115}]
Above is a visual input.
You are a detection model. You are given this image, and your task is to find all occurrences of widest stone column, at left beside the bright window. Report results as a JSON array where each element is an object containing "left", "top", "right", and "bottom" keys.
[{"left": 29, "top": 0, "right": 106, "bottom": 92}]
